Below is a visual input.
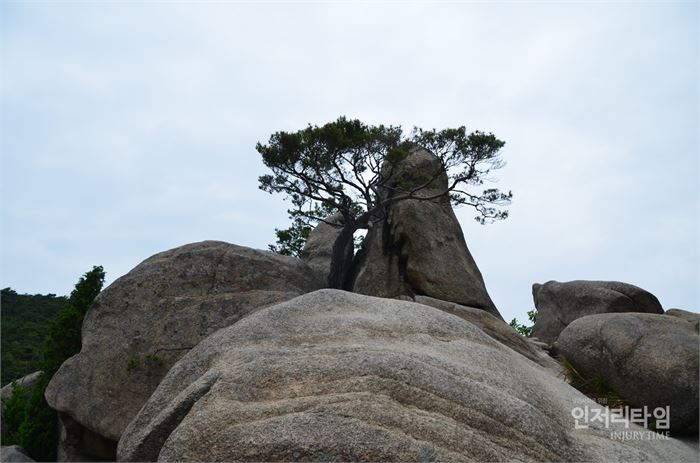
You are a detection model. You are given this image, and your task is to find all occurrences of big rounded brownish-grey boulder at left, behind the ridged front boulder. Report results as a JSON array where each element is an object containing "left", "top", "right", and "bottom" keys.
[{"left": 46, "top": 241, "right": 321, "bottom": 441}]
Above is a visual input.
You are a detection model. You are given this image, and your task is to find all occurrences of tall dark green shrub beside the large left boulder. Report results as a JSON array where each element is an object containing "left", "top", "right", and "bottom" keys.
[{"left": 3, "top": 267, "right": 105, "bottom": 461}]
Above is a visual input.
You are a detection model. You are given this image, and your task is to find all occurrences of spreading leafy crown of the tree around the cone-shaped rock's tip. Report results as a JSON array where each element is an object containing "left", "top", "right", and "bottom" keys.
[{"left": 256, "top": 117, "right": 512, "bottom": 228}]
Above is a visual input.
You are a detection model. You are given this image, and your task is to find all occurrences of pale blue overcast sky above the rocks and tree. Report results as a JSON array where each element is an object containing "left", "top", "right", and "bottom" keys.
[{"left": 1, "top": 1, "right": 698, "bottom": 320}]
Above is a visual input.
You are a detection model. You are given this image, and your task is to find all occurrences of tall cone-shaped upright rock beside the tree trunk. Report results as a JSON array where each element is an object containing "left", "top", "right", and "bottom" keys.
[{"left": 353, "top": 149, "right": 502, "bottom": 318}]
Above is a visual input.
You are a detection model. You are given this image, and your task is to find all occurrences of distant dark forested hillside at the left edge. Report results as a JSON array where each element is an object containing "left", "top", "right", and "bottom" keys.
[{"left": 0, "top": 288, "right": 67, "bottom": 386}]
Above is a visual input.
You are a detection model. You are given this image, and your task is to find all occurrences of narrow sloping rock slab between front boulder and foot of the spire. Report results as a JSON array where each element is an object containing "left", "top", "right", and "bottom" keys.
[{"left": 414, "top": 296, "right": 561, "bottom": 374}]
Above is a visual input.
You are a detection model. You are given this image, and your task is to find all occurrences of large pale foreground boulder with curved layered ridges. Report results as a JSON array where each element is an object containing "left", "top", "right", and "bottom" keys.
[{"left": 118, "top": 289, "right": 697, "bottom": 461}]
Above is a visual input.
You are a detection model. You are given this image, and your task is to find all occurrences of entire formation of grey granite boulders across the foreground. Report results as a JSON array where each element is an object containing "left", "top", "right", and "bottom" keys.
[{"left": 2, "top": 150, "right": 700, "bottom": 462}]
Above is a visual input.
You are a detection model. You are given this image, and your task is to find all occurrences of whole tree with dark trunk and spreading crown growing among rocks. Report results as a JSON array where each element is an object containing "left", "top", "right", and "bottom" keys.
[{"left": 256, "top": 117, "right": 512, "bottom": 288}]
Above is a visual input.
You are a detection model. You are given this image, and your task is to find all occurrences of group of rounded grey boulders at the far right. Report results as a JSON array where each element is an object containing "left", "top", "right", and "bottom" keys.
[{"left": 532, "top": 281, "right": 700, "bottom": 437}]
